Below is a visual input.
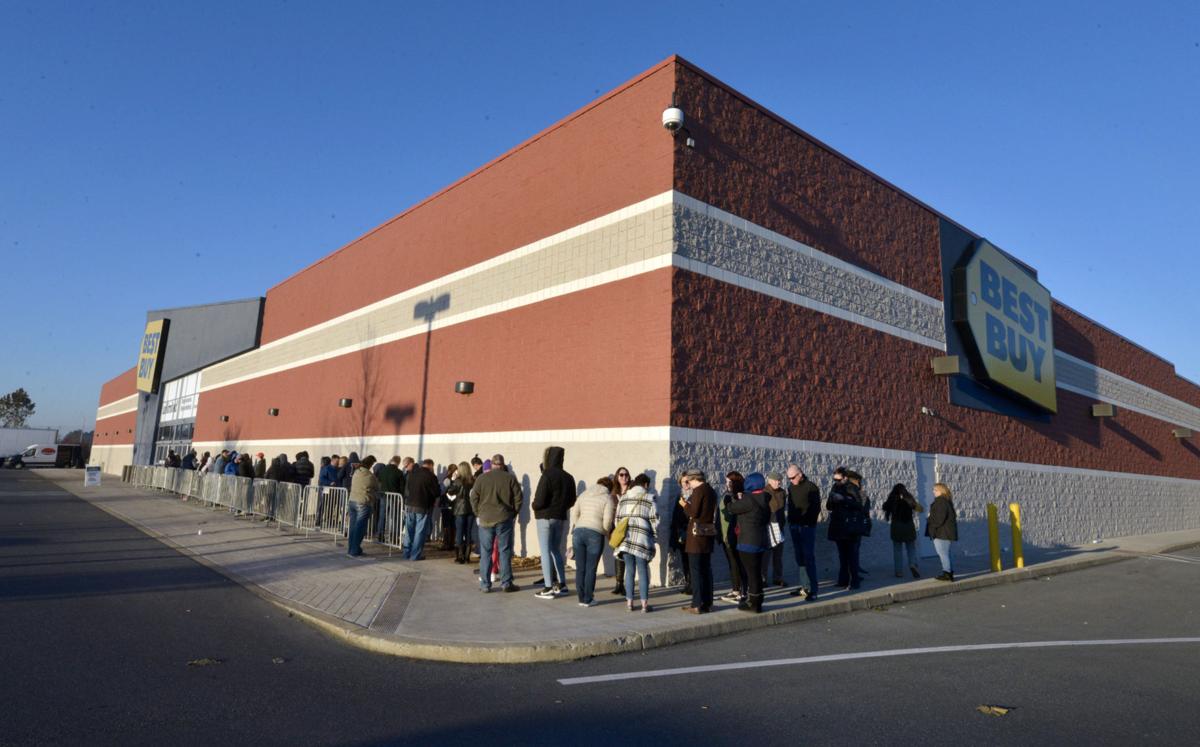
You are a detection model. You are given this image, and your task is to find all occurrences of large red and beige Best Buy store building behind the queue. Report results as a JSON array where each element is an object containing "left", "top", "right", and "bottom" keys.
[{"left": 94, "top": 58, "right": 1200, "bottom": 574}]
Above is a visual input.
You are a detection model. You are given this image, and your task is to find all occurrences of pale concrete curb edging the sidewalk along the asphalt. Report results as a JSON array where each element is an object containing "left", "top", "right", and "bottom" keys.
[{"left": 39, "top": 478, "right": 1198, "bottom": 664}]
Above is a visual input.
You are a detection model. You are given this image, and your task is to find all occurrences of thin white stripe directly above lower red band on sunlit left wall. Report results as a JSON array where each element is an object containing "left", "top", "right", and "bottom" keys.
[{"left": 200, "top": 253, "right": 671, "bottom": 393}]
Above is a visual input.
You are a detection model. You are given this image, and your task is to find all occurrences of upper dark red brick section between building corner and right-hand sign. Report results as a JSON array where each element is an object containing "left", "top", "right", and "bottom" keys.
[{"left": 674, "top": 62, "right": 942, "bottom": 298}]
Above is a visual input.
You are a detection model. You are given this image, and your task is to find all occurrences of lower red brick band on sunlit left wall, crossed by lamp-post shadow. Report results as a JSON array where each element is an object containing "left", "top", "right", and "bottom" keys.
[{"left": 196, "top": 268, "right": 671, "bottom": 441}]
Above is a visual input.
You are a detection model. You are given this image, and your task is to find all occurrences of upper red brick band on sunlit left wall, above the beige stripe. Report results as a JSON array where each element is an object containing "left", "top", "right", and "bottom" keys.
[{"left": 256, "top": 60, "right": 674, "bottom": 343}]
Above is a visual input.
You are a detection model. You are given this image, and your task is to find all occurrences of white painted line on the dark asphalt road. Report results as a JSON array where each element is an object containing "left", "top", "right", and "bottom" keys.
[{"left": 558, "top": 638, "right": 1200, "bottom": 686}]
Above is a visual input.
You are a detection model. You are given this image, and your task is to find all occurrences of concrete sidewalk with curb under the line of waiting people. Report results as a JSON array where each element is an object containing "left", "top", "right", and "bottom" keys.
[{"left": 35, "top": 470, "right": 1200, "bottom": 663}]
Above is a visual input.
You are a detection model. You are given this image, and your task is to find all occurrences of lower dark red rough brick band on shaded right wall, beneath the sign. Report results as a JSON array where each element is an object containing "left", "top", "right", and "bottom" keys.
[{"left": 671, "top": 270, "right": 1200, "bottom": 479}]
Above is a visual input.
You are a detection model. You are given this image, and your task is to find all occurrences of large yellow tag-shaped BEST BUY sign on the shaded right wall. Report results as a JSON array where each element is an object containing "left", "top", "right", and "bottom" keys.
[{"left": 954, "top": 239, "right": 1058, "bottom": 412}]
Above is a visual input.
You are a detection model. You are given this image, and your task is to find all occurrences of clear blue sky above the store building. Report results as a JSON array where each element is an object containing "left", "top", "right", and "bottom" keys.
[{"left": 0, "top": 0, "right": 1200, "bottom": 429}]
